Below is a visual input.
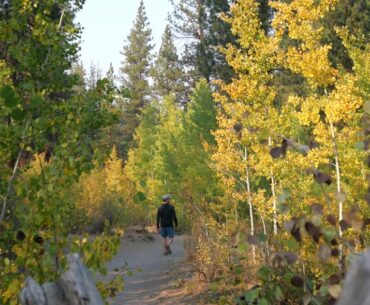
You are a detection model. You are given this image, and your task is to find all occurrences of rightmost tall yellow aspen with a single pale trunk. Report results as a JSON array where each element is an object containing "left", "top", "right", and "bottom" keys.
[{"left": 272, "top": 1, "right": 365, "bottom": 236}]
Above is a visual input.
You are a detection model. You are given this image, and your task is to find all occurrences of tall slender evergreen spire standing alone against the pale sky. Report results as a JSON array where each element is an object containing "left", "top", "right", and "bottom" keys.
[{"left": 120, "top": 1, "right": 153, "bottom": 150}]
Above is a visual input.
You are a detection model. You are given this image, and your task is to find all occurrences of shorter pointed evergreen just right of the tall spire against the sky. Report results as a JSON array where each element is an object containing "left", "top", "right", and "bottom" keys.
[{"left": 151, "top": 25, "right": 185, "bottom": 103}]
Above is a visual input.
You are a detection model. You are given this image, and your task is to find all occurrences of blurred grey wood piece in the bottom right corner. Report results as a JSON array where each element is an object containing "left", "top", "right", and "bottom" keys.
[{"left": 336, "top": 250, "right": 370, "bottom": 305}]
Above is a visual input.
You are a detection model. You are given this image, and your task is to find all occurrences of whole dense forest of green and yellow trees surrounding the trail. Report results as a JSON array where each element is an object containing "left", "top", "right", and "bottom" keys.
[{"left": 0, "top": 0, "right": 370, "bottom": 305}]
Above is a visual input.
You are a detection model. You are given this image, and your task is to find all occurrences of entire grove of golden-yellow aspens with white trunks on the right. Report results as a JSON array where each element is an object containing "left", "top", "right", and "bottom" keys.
[{"left": 214, "top": 0, "right": 369, "bottom": 304}]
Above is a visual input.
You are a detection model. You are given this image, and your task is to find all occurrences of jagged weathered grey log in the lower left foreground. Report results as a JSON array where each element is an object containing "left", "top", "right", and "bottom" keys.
[{"left": 20, "top": 254, "right": 104, "bottom": 305}]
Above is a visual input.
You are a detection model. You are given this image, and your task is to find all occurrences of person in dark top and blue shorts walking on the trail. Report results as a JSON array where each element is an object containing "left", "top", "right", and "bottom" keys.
[{"left": 157, "top": 195, "right": 177, "bottom": 255}]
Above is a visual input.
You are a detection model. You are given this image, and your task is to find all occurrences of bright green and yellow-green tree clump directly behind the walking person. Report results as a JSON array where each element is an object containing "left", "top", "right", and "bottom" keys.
[{"left": 126, "top": 81, "right": 220, "bottom": 227}]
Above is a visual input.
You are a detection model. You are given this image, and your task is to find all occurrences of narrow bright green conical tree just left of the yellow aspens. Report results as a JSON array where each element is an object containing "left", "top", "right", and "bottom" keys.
[{"left": 178, "top": 79, "right": 222, "bottom": 202}]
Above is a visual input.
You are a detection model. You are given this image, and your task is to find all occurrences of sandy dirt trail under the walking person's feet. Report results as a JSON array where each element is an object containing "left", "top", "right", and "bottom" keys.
[{"left": 108, "top": 234, "right": 195, "bottom": 305}]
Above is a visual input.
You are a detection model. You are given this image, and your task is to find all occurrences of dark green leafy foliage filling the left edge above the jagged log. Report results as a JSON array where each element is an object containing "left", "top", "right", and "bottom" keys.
[{"left": 0, "top": 0, "right": 124, "bottom": 305}]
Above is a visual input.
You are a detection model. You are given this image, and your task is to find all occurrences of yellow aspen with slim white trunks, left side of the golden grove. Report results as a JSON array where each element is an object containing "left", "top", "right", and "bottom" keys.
[{"left": 215, "top": 1, "right": 279, "bottom": 240}]
